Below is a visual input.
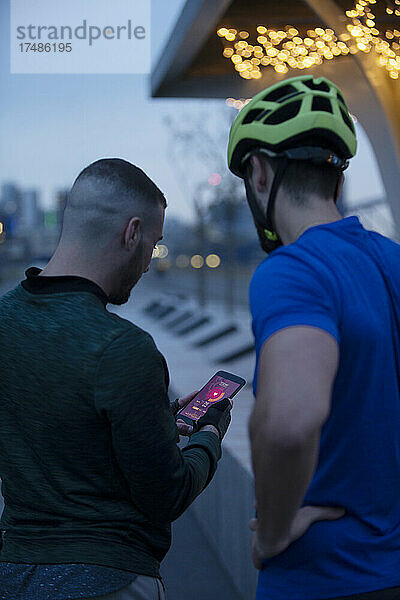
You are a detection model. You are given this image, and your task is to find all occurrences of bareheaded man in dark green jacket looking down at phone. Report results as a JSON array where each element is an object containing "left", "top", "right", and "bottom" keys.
[{"left": 0, "top": 159, "right": 231, "bottom": 600}]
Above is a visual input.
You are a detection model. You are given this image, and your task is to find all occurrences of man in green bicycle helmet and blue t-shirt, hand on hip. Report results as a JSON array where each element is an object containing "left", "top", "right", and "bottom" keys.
[{"left": 228, "top": 75, "right": 400, "bottom": 600}]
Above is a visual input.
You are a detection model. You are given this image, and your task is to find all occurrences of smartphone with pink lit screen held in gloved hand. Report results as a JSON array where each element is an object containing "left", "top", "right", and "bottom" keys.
[{"left": 176, "top": 371, "right": 246, "bottom": 426}]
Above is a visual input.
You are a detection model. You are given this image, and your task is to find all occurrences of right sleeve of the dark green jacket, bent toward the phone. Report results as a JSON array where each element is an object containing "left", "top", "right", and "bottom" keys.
[{"left": 94, "top": 325, "right": 221, "bottom": 523}]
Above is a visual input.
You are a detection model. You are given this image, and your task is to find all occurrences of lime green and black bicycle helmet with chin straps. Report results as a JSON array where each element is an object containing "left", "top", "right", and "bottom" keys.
[{"left": 228, "top": 75, "right": 357, "bottom": 251}]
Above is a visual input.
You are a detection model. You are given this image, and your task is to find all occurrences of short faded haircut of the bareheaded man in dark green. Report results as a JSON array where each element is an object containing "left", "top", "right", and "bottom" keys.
[{"left": 61, "top": 158, "right": 167, "bottom": 244}]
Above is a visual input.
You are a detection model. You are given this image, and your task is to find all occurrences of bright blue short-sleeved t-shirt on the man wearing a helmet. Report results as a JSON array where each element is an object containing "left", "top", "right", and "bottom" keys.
[{"left": 250, "top": 217, "right": 400, "bottom": 600}]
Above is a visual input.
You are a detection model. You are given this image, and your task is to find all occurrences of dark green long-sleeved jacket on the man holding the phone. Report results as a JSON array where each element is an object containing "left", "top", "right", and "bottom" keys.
[{"left": 0, "top": 267, "right": 221, "bottom": 576}]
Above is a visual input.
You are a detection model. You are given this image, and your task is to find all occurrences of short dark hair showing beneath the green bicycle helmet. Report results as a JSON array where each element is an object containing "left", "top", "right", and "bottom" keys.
[{"left": 249, "top": 153, "right": 341, "bottom": 206}]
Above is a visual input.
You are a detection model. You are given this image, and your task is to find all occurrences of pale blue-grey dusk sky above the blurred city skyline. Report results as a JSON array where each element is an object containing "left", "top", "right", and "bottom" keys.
[{"left": 0, "top": 0, "right": 384, "bottom": 220}]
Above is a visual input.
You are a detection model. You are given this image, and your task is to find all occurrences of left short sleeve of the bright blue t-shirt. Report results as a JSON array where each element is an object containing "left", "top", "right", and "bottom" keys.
[{"left": 250, "top": 252, "right": 340, "bottom": 354}]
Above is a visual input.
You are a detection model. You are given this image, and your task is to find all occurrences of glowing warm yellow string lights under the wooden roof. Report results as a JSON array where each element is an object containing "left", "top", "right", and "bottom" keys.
[{"left": 217, "top": 0, "right": 400, "bottom": 81}]
